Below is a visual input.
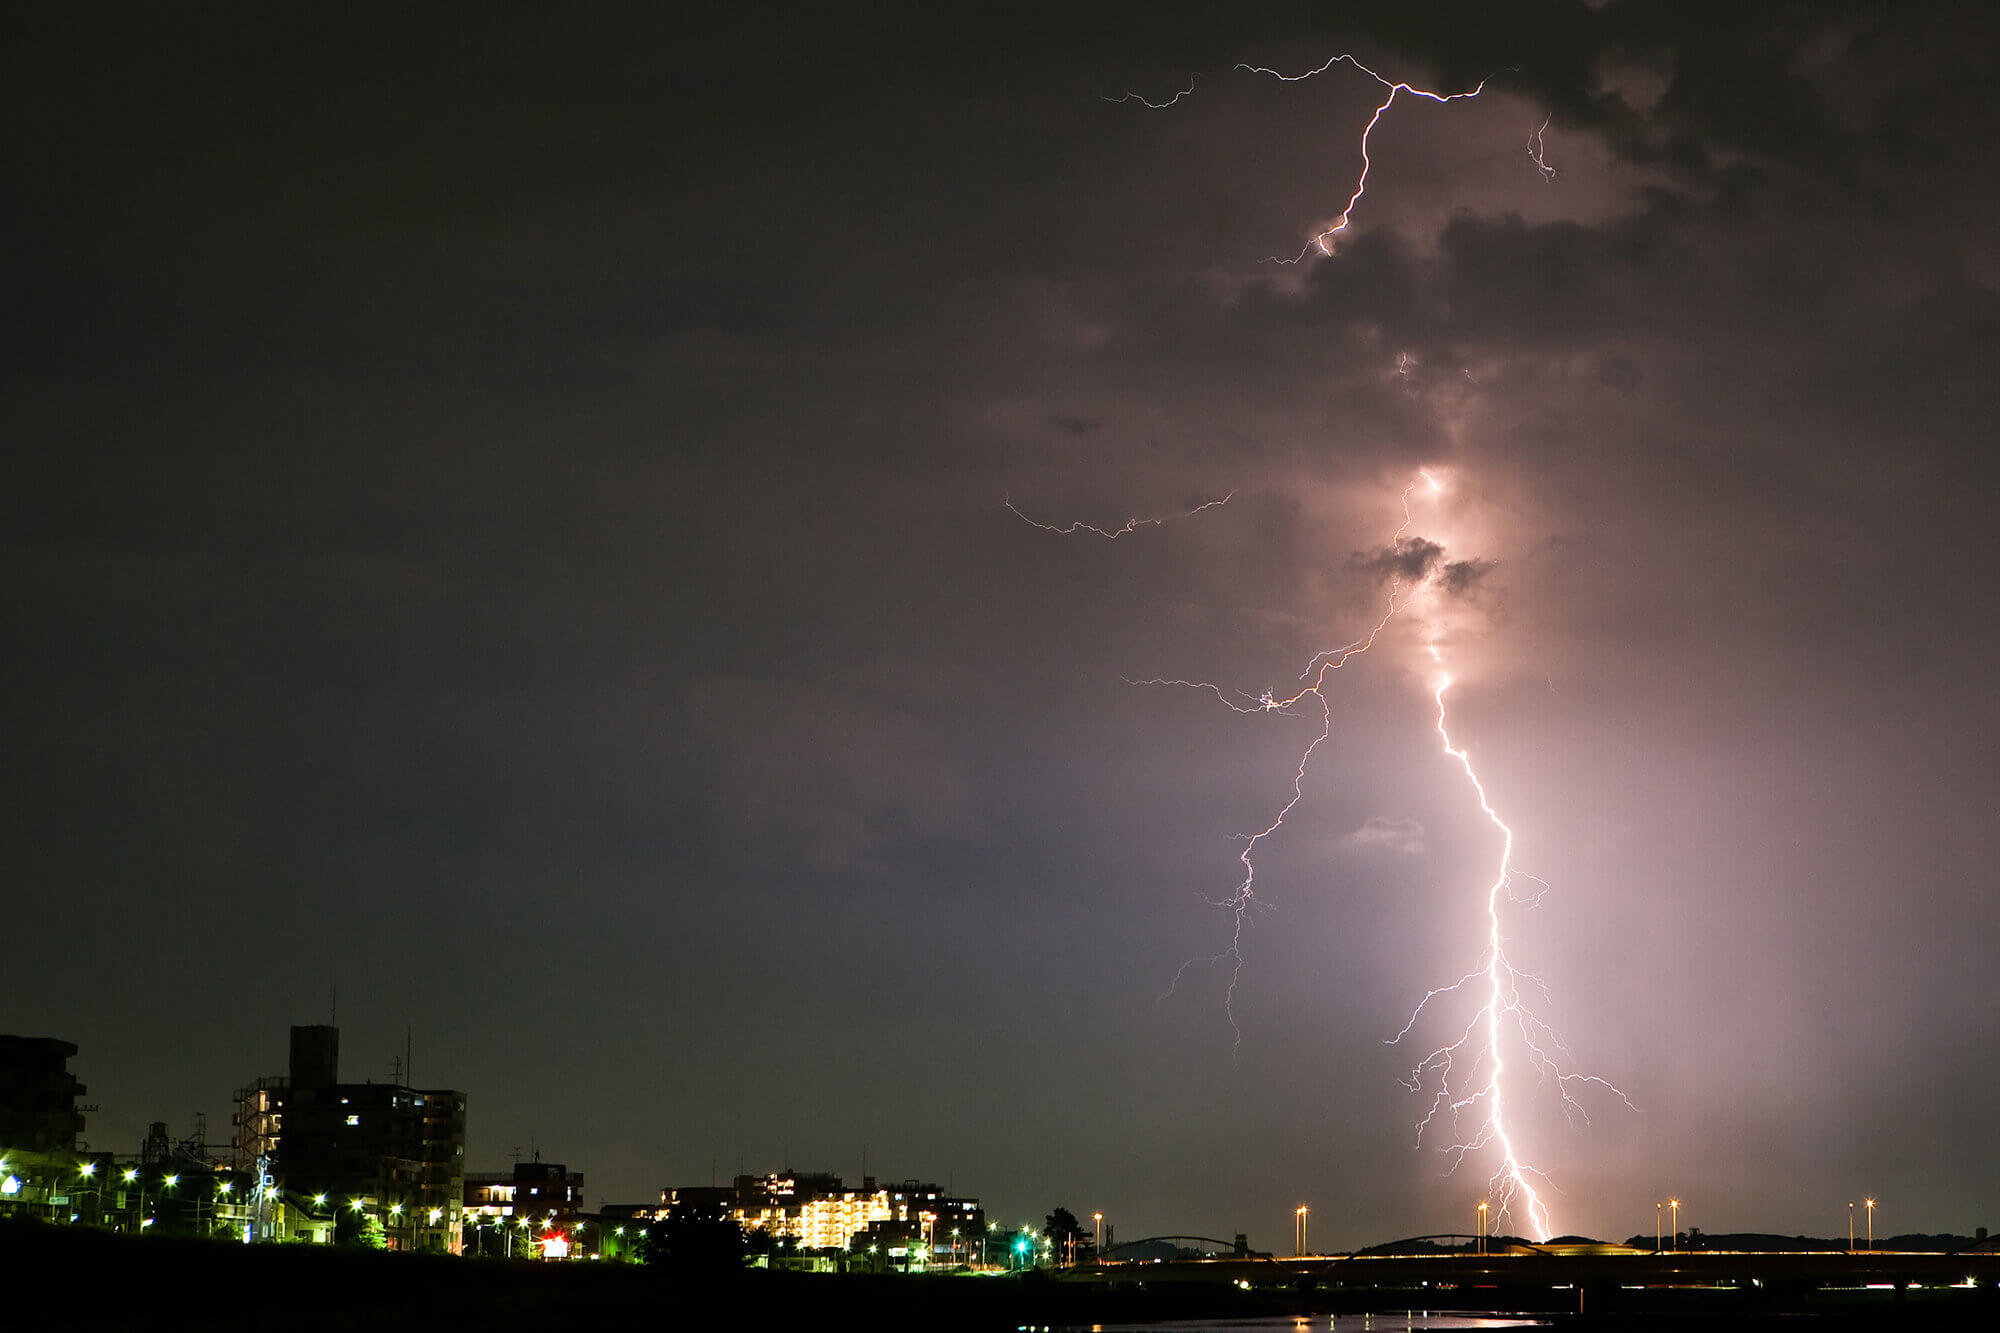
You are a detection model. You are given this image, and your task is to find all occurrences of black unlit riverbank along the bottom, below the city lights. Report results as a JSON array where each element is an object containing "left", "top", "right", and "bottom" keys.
[{"left": 0, "top": 1223, "right": 2000, "bottom": 1333}]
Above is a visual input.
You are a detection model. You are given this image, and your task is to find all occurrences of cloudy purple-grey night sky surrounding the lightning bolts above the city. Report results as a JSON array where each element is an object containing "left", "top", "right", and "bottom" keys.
[{"left": 0, "top": 0, "right": 2000, "bottom": 1249}]
